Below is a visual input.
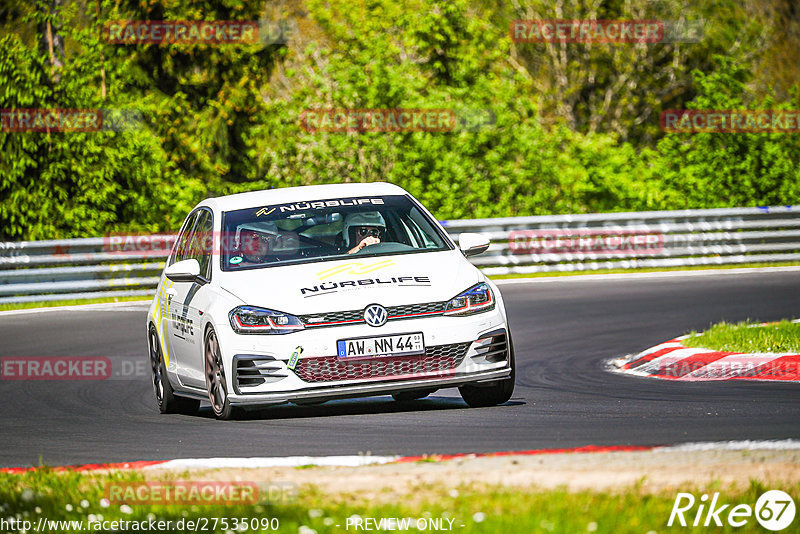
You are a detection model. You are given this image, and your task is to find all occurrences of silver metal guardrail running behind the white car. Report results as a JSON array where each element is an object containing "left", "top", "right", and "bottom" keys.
[{"left": 0, "top": 206, "right": 800, "bottom": 303}]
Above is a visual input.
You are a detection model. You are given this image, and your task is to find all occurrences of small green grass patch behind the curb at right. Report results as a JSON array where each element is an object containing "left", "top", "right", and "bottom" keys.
[{"left": 682, "top": 321, "right": 800, "bottom": 352}]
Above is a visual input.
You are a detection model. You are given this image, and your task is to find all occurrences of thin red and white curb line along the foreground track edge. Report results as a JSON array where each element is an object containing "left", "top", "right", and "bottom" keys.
[{"left": 0, "top": 439, "right": 800, "bottom": 474}]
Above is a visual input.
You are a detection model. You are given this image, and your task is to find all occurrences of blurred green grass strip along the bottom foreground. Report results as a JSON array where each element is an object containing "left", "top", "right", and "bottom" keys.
[{"left": 0, "top": 469, "right": 800, "bottom": 534}]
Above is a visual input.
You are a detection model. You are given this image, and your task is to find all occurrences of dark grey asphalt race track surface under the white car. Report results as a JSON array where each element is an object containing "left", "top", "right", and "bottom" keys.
[{"left": 0, "top": 271, "right": 800, "bottom": 467}]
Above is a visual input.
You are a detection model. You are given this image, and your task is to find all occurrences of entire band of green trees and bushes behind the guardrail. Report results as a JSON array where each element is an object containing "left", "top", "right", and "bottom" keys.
[{"left": 0, "top": 0, "right": 800, "bottom": 239}]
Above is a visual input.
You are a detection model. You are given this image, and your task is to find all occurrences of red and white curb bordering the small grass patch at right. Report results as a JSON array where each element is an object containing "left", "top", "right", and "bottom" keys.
[{"left": 608, "top": 336, "right": 800, "bottom": 382}]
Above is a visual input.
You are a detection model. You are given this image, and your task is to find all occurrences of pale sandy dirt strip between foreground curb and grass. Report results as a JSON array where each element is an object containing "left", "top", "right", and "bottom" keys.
[{"left": 144, "top": 450, "right": 800, "bottom": 501}]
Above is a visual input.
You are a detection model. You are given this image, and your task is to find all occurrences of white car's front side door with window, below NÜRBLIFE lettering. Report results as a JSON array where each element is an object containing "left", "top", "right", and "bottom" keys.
[{"left": 168, "top": 208, "right": 214, "bottom": 389}]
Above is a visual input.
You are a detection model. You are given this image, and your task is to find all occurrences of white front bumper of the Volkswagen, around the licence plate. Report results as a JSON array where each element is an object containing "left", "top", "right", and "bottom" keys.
[{"left": 218, "top": 309, "right": 511, "bottom": 406}]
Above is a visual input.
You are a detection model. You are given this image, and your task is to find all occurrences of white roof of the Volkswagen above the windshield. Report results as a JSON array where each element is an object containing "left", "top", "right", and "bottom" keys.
[{"left": 197, "top": 182, "right": 408, "bottom": 212}]
